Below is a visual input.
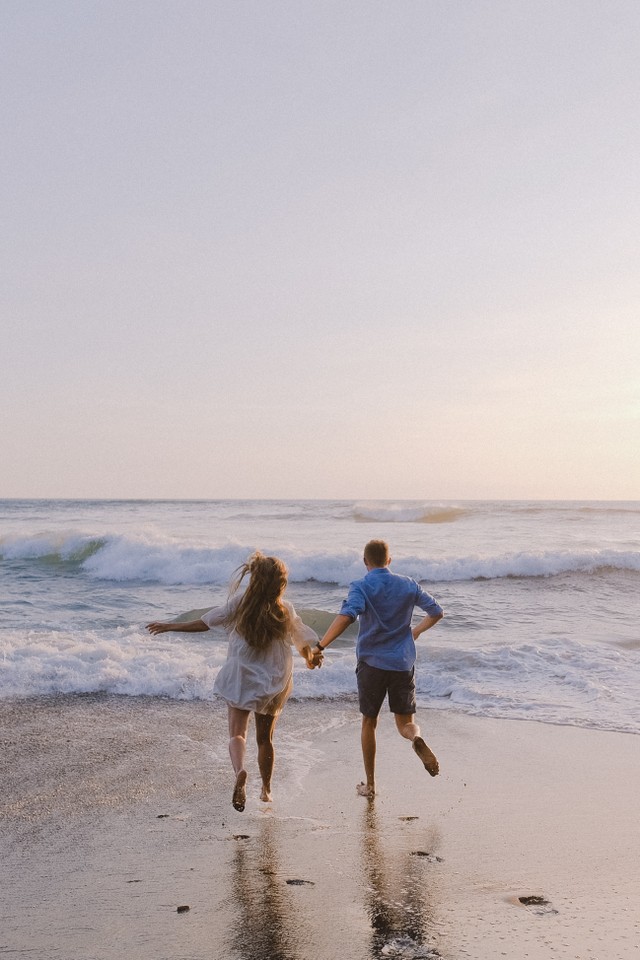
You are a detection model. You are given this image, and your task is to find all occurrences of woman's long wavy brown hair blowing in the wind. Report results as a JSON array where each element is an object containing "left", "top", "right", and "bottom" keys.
[{"left": 225, "top": 551, "right": 289, "bottom": 650}]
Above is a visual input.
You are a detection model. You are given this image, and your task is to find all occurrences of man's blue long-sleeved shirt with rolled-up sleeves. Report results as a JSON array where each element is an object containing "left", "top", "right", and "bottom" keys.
[{"left": 340, "top": 567, "right": 442, "bottom": 670}]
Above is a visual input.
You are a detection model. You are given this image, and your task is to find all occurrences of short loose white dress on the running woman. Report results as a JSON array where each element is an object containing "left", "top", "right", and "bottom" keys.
[{"left": 202, "top": 598, "right": 318, "bottom": 716}]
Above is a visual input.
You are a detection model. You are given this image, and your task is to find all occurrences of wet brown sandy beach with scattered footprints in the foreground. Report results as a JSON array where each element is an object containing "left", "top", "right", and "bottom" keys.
[{"left": 0, "top": 695, "right": 640, "bottom": 960}]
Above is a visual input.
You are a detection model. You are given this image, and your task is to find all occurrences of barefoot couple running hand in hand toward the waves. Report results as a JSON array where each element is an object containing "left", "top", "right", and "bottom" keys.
[{"left": 147, "top": 540, "right": 443, "bottom": 811}]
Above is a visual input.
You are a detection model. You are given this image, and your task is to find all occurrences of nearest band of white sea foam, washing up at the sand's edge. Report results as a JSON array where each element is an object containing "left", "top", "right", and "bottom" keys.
[{"left": 0, "top": 628, "right": 640, "bottom": 733}]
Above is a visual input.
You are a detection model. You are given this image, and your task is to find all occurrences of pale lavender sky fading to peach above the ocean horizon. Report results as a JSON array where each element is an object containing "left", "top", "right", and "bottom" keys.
[{"left": 0, "top": 0, "right": 640, "bottom": 500}]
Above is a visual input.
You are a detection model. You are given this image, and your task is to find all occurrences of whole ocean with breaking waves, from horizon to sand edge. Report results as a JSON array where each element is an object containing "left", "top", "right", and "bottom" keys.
[{"left": 0, "top": 500, "right": 640, "bottom": 733}]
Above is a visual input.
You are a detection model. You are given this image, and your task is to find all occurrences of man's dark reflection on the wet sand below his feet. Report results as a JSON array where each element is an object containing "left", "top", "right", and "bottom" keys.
[{"left": 362, "top": 803, "right": 441, "bottom": 960}]
